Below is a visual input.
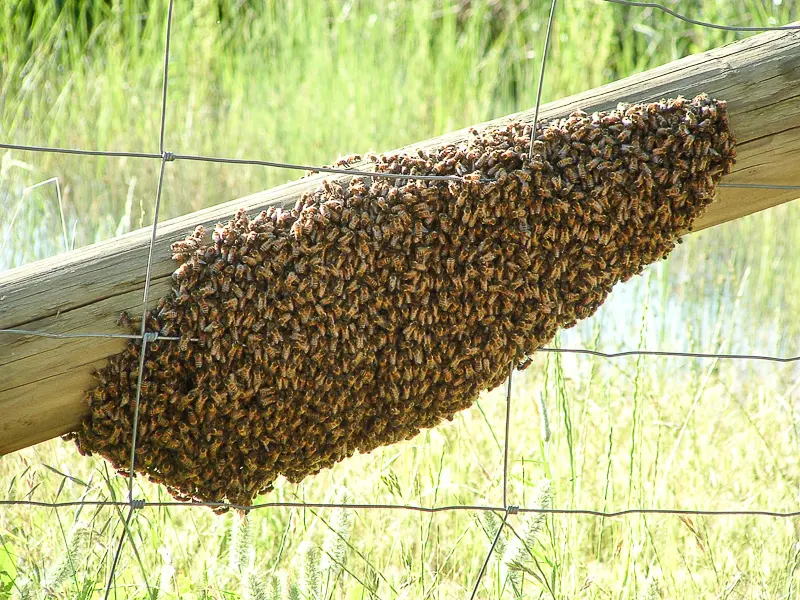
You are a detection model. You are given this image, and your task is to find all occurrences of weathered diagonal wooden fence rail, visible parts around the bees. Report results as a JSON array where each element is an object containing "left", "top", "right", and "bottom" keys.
[{"left": 0, "top": 24, "right": 800, "bottom": 454}]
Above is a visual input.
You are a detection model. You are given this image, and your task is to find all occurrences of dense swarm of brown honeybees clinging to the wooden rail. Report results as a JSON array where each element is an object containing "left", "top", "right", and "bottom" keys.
[{"left": 69, "top": 96, "right": 735, "bottom": 509}]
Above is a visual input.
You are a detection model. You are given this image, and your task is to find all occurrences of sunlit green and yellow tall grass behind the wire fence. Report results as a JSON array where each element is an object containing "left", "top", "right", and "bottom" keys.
[{"left": 0, "top": 0, "right": 800, "bottom": 600}]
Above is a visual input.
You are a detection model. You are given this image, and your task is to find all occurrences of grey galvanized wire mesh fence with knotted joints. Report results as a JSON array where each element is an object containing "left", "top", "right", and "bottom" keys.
[{"left": 0, "top": 0, "right": 800, "bottom": 598}]
